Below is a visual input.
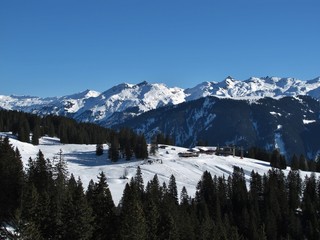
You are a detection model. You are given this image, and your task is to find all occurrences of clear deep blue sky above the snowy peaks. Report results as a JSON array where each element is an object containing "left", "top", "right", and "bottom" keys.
[{"left": 0, "top": 0, "right": 320, "bottom": 97}]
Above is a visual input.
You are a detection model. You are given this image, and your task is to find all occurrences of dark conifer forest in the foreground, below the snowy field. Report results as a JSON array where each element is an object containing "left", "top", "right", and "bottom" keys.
[{"left": 0, "top": 138, "right": 320, "bottom": 240}]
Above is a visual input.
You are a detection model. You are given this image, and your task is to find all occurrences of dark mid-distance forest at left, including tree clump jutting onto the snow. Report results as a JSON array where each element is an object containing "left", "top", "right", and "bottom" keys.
[{"left": 0, "top": 110, "right": 150, "bottom": 162}]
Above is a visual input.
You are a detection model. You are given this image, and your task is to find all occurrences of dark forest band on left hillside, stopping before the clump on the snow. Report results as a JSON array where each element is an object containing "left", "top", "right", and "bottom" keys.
[{"left": 0, "top": 110, "right": 112, "bottom": 145}]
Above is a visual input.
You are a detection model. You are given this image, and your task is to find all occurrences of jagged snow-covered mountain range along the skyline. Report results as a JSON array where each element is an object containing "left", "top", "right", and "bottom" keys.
[{"left": 0, "top": 77, "right": 320, "bottom": 126}]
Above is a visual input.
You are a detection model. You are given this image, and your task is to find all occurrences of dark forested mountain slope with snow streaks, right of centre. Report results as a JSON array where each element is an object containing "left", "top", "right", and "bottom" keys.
[{"left": 118, "top": 96, "right": 320, "bottom": 158}]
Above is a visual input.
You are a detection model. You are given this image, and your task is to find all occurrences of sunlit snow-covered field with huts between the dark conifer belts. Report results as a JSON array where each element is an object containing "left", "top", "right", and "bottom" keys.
[{"left": 1, "top": 133, "right": 318, "bottom": 204}]
